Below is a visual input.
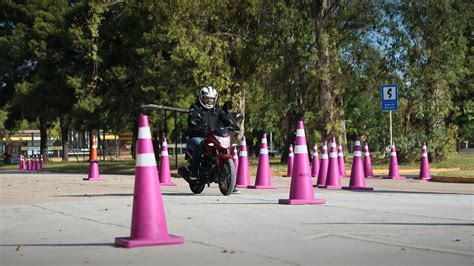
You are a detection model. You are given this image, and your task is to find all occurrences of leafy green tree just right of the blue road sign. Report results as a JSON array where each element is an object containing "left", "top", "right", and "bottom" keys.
[{"left": 390, "top": 1, "right": 472, "bottom": 161}]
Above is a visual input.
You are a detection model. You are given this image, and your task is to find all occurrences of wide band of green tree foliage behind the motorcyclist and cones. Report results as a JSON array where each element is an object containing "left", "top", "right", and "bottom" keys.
[{"left": 0, "top": 0, "right": 474, "bottom": 162}]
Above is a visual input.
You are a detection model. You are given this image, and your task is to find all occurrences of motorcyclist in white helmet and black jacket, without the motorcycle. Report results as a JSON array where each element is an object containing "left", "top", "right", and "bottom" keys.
[{"left": 186, "top": 86, "right": 239, "bottom": 183}]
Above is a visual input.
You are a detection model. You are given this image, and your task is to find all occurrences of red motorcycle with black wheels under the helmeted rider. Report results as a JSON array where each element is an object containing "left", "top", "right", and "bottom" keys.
[{"left": 178, "top": 124, "right": 236, "bottom": 196}]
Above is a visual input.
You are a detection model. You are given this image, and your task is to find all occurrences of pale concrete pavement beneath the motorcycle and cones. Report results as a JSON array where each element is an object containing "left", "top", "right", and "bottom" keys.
[{"left": 0, "top": 171, "right": 474, "bottom": 265}]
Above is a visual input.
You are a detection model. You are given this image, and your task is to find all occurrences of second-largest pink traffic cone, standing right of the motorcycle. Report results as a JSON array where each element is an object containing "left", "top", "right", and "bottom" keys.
[{"left": 278, "top": 121, "right": 326, "bottom": 205}]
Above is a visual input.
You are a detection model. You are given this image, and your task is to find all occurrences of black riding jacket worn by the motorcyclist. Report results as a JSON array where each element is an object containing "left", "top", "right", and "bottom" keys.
[{"left": 188, "top": 100, "right": 232, "bottom": 138}]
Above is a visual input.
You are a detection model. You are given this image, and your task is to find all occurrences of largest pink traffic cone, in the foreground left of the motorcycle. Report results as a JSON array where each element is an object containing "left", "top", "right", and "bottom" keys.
[{"left": 115, "top": 115, "right": 184, "bottom": 248}]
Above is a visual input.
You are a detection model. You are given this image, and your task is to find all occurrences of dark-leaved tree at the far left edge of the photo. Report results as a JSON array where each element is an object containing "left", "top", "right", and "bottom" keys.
[{"left": 0, "top": 1, "right": 70, "bottom": 156}]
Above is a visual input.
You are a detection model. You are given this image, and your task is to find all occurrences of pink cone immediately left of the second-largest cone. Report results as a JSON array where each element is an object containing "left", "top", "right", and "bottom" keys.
[{"left": 249, "top": 134, "right": 278, "bottom": 189}]
